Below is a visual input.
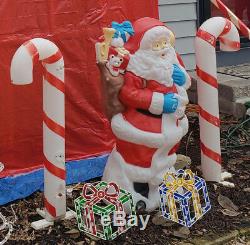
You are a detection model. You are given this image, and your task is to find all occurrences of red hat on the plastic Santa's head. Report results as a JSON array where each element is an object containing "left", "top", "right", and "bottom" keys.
[{"left": 124, "top": 17, "right": 172, "bottom": 54}]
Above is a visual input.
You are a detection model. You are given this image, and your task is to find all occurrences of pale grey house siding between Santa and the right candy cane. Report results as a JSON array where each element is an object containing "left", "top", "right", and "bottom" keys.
[{"left": 159, "top": 0, "right": 197, "bottom": 70}]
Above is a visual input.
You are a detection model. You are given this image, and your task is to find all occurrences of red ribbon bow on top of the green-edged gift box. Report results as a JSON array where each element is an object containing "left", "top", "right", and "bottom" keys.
[{"left": 82, "top": 182, "right": 120, "bottom": 206}]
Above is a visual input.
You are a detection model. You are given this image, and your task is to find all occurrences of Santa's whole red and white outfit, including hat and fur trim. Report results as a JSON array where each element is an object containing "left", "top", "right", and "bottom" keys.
[{"left": 103, "top": 18, "right": 190, "bottom": 210}]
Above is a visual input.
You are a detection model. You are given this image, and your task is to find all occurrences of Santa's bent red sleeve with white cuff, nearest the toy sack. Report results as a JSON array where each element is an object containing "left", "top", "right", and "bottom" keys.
[{"left": 119, "top": 72, "right": 164, "bottom": 115}]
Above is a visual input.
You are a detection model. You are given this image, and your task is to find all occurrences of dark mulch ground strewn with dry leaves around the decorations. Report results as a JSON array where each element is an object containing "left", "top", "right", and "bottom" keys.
[{"left": 0, "top": 106, "right": 250, "bottom": 245}]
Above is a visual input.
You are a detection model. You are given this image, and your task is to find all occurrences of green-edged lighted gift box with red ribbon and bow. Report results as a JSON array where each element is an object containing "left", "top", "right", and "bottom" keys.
[{"left": 74, "top": 181, "right": 135, "bottom": 240}]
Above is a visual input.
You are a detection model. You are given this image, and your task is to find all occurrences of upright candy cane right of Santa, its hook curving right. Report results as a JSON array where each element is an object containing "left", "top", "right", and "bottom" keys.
[{"left": 195, "top": 17, "right": 240, "bottom": 182}]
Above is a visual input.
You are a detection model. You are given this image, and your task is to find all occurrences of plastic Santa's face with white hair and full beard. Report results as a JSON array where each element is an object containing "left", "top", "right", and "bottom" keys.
[{"left": 127, "top": 26, "right": 178, "bottom": 86}]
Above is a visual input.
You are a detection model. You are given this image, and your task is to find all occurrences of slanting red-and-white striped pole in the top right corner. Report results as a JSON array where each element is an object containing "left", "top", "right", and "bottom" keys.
[{"left": 210, "top": 0, "right": 250, "bottom": 39}]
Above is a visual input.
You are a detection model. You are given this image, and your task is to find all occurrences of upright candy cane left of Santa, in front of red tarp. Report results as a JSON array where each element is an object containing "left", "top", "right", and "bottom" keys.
[{"left": 11, "top": 38, "right": 66, "bottom": 221}]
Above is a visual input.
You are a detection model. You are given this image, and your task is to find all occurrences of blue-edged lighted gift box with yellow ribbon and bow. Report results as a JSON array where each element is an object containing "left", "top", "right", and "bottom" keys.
[{"left": 159, "top": 169, "right": 211, "bottom": 227}]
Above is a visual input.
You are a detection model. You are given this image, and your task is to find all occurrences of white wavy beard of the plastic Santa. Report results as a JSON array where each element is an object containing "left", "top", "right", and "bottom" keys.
[{"left": 127, "top": 48, "right": 178, "bottom": 86}]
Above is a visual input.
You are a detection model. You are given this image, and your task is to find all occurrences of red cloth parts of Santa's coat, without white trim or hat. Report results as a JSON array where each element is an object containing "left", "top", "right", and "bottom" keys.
[{"left": 116, "top": 72, "right": 182, "bottom": 168}]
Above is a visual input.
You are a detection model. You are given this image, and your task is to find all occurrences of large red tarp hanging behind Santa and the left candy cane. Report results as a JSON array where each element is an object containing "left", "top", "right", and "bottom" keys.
[{"left": 0, "top": 0, "right": 158, "bottom": 177}]
